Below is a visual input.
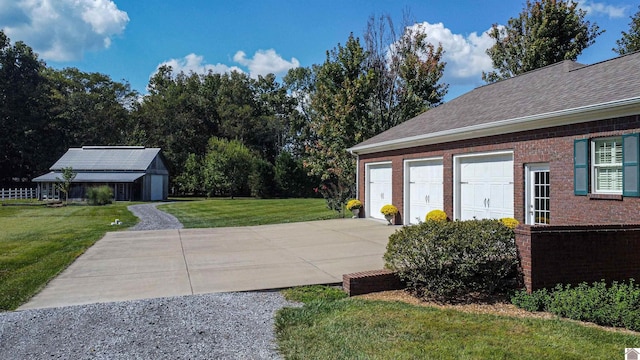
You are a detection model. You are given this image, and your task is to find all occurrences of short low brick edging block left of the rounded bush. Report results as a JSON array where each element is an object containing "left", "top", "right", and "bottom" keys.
[{"left": 342, "top": 269, "right": 406, "bottom": 296}]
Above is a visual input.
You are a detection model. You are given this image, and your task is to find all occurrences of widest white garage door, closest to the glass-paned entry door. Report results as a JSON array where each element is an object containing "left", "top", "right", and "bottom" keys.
[{"left": 456, "top": 154, "right": 513, "bottom": 220}]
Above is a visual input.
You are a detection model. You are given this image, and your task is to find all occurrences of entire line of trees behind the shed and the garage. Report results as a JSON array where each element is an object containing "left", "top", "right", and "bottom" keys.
[{"left": 0, "top": 0, "right": 640, "bottom": 205}]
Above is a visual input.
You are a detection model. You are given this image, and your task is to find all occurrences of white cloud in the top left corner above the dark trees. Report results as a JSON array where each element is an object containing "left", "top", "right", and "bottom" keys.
[{"left": 0, "top": 0, "right": 129, "bottom": 61}]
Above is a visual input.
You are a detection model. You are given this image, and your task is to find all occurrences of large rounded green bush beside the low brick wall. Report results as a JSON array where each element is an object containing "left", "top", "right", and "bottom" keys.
[{"left": 384, "top": 220, "right": 519, "bottom": 300}]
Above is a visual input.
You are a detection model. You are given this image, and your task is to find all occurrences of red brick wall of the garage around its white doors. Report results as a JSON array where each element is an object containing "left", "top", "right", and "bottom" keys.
[{"left": 358, "top": 115, "right": 640, "bottom": 225}]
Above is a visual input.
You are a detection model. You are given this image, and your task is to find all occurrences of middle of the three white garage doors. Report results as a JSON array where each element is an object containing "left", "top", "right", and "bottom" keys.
[{"left": 405, "top": 160, "right": 444, "bottom": 224}]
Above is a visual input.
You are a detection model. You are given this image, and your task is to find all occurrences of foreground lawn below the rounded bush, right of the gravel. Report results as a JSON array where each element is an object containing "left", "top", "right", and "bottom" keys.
[{"left": 276, "top": 286, "right": 640, "bottom": 359}]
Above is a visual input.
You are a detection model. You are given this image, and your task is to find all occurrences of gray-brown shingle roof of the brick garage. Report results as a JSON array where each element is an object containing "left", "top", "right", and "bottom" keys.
[{"left": 351, "top": 52, "right": 640, "bottom": 152}]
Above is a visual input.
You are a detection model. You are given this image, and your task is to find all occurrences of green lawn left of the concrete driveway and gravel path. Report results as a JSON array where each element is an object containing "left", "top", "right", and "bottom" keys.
[{"left": 0, "top": 203, "right": 138, "bottom": 311}]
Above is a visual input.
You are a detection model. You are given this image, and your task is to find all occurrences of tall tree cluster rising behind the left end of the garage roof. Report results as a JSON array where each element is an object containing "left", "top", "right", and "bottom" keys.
[{"left": 298, "top": 16, "right": 447, "bottom": 211}]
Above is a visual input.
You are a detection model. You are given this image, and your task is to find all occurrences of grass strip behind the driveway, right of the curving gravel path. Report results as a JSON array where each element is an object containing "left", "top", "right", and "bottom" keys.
[{"left": 158, "top": 199, "right": 338, "bottom": 228}]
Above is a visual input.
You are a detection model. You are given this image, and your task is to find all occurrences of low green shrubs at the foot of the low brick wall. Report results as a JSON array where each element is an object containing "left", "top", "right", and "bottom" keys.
[{"left": 511, "top": 280, "right": 640, "bottom": 331}]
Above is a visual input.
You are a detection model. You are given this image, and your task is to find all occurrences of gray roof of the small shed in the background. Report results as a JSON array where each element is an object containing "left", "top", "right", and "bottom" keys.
[{"left": 50, "top": 146, "right": 160, "bottom": 172}]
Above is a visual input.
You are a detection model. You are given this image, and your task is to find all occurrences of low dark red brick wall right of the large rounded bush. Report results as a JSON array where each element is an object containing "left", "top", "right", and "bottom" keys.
[{"left": 516, "top": 225, "right": 640, "bottom": 292}]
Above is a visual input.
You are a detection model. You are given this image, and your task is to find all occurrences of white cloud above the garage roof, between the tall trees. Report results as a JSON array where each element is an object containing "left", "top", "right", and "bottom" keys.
[{"left": 404, "top": 22, "right": 494, "bottom": 85}]
